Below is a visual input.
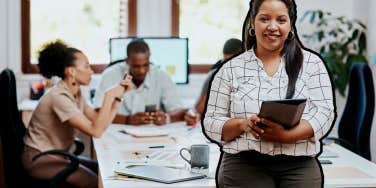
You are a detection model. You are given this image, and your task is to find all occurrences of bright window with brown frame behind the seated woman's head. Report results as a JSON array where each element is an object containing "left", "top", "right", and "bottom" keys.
[{"left": 21, "top": 0, "right": 137, "bottom": 73}]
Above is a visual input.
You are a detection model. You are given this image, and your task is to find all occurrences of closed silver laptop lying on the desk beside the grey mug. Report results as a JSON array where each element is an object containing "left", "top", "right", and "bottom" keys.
[{"left": 115, "top": 165, "right": 206, "bottom": 184}]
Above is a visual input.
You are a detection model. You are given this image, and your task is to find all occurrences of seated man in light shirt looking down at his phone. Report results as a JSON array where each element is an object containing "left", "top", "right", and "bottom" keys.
[{"left": 94, "top": 39, "right": 195, "bottom": 125}]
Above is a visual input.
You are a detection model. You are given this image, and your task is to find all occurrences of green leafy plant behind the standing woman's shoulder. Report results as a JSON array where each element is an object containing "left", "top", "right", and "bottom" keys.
[{"left": 299, "top": 10, "right": 367, "bottom": 96}]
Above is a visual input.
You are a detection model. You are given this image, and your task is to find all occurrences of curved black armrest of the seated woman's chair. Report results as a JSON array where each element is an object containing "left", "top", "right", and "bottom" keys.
[{"left": 32, "top": 150, "right": 79, "bottom": 188}]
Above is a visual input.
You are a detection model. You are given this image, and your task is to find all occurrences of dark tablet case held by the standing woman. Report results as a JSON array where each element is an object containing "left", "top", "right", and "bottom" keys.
[{"left": 257, "top": 99, "right": 307, "bottom": 129}]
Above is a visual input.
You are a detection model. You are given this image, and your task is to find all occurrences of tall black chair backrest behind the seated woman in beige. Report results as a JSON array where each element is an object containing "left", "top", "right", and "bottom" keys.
[{"left": 0, "top": 69, "right": 26, "bottom": 187}]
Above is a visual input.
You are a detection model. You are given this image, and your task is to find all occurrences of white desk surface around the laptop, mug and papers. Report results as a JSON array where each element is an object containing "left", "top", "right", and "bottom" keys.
[{"left": 93, "top": 122, "right": 376, "bottom": 188}]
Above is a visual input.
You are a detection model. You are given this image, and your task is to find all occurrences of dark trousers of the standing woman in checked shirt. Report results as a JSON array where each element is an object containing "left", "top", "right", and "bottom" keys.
[{"left": 218, "top": 151, "right": 323, "bottom": 188}]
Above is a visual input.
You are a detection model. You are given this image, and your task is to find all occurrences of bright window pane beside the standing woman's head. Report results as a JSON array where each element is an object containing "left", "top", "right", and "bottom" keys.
[{"left": 178, "top": 0, "right": 249, "bottom": 64}]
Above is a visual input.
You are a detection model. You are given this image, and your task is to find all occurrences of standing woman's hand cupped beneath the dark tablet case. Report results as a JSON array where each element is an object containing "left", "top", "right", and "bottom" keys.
[{"left": 261, "top": 118, "right": 293, "bottom": 143}]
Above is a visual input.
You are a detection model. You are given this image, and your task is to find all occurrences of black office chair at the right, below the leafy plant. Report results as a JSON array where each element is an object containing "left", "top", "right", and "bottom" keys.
[{"left": 327, "top": 63, "right": 375, "bottom": 160}]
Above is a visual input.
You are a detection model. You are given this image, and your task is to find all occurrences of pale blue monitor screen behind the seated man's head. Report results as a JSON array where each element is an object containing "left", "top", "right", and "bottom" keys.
[{"left": 110, "top": 37, "right": 188, "bottom": 84}]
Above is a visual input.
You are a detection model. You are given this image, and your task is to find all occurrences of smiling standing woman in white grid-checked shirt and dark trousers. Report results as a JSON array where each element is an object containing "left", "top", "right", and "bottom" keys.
[{"left": 204, "top": 0, "right": 335, "bottom": 188}]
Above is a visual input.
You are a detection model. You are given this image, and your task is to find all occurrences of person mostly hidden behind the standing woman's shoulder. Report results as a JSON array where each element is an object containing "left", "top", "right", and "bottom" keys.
[{"left": 192, "top": 38, "right": 243, "bottom": 114}]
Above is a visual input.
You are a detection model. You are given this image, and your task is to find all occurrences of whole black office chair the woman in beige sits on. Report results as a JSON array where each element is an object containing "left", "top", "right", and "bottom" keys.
[{"left": 0, "top": 69, "right": 83, "bottom": 187}]
